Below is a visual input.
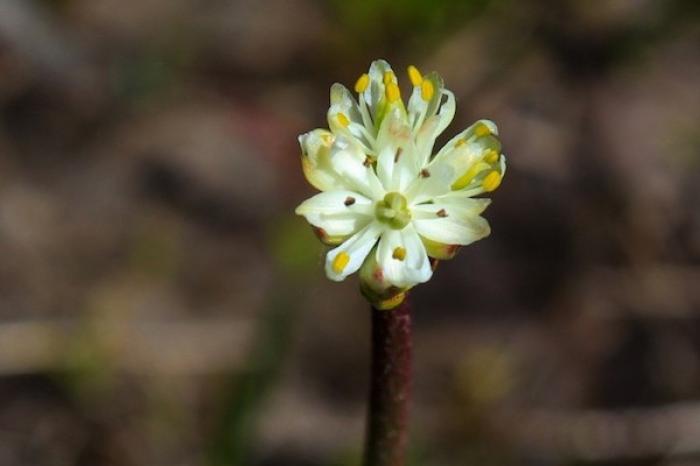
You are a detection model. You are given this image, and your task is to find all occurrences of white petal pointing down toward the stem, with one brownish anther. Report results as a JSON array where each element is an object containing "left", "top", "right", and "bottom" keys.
[{"left": 376, "top": 226, "right": 432, "bottom": 288}]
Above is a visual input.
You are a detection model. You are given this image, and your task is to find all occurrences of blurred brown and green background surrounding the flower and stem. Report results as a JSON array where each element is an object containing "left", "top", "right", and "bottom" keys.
[{"left": 0, "top": 0, "right": 700, "bottom": 466}]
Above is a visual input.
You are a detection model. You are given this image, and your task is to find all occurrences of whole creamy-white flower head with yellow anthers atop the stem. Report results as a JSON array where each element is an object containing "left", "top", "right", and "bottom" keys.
[{"left": 296, "top": 60, "right": 506, "bottom": 308}]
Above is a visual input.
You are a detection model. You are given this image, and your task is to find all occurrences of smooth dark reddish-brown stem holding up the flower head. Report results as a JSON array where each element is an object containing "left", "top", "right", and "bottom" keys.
[{"left": 365, "top": 297, "right": 413, "bottom": 466}]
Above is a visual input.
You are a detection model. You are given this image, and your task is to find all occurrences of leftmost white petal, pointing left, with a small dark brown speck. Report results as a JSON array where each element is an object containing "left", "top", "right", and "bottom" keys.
[{"left": 295, "top": 191, "right": 374, "bottom": 236}]
